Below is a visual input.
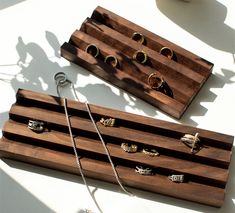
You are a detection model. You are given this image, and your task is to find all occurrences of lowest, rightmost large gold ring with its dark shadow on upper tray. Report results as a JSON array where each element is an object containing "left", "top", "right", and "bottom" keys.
[{"left": 148, "top": 72, "right": 173, "bottom": 98}]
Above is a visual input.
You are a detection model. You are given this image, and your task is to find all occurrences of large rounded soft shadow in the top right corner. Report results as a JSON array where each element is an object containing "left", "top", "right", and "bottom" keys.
[{"left": 156, "top": 0, "right": 235, "bottom": 54}]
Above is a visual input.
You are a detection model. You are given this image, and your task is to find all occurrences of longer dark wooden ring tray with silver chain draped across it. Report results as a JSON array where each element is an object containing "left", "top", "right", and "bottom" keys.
[{"left": 0, "top": 90, "right": 233, "bottom": 207}]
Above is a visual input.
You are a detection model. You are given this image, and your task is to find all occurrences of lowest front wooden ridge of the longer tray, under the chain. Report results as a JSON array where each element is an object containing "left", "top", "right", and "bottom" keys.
[{"left": 0, "top": 138, "right": 224, "bottom": 207}]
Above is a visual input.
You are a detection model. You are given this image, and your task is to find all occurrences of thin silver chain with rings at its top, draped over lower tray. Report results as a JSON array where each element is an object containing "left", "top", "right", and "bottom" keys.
[{"left": 54, "top": 72, "right": 133, "bottom": 210}]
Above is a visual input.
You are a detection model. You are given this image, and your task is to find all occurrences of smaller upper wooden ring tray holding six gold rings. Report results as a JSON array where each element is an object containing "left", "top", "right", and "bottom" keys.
[{"left": 61, "top": 7, "right": 213, "bottom": 118}]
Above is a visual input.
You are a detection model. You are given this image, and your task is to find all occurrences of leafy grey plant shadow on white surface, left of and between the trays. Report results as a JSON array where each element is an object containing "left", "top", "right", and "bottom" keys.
[{"left": 1, "top": 31, "right": 159, "bottom": 116}]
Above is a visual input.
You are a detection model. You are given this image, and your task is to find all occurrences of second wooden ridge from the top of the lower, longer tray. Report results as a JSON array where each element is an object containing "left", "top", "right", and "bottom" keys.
[{"left": 9, "top": 105, "right": 231, "bottom": 170}]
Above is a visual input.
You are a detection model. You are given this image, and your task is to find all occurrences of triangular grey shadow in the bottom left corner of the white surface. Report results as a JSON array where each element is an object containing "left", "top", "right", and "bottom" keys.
[{"left": 0, "top": 169, "right": 54, "bottom": 213}]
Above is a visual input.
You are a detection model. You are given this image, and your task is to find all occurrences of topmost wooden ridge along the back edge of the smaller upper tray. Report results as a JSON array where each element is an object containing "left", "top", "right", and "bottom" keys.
[{"left": 91, "top": 6, "right": 213, "bottom": 77}]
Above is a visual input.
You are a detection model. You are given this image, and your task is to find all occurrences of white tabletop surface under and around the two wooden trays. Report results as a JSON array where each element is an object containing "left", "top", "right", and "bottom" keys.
[{"left": 0, "top": 0, "right": 235, "bottom": 213}]
